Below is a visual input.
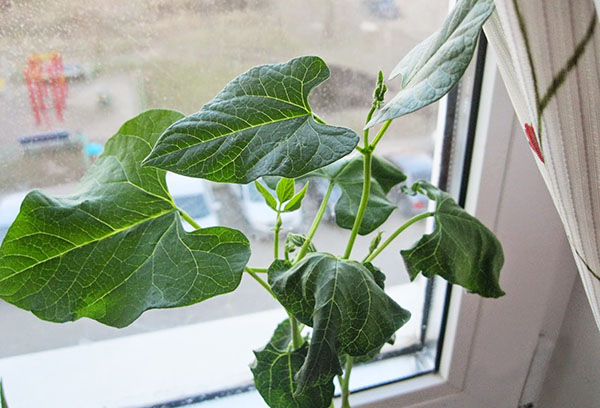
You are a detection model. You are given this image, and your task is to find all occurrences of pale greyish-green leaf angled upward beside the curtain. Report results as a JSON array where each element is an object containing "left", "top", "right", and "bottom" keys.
[{"left": 366, "top": 0, "right": 494, "bottom": 128}]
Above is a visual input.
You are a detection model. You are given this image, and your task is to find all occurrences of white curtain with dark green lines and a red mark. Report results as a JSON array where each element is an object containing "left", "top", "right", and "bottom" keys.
[{"left": 485, "top": 0, "right": 600, "bottom": 328}]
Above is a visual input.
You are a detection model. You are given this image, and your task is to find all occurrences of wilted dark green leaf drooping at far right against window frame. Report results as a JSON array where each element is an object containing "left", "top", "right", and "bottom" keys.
[{"left": 401, "top": 181, "right": 504, "bottom": 298}]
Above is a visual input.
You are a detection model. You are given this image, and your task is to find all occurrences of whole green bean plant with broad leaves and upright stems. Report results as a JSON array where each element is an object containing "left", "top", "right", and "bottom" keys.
[{"left": 0, "top": 0, "right": 503, "bottom": 408}]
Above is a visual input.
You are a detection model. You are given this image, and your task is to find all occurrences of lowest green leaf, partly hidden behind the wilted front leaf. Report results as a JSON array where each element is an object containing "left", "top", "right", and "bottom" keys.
[{"left": 251, "top": 320, "right": 334, "bottom": 408}]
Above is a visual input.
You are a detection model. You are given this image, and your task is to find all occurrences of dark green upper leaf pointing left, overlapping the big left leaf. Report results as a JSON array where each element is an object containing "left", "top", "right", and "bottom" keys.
[{"left": 144, "top": 56, "right": 358, "bottom": 183}]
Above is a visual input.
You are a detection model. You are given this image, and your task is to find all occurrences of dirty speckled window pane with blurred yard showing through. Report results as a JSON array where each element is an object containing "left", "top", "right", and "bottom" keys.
[{"left": 0, "top": 0, "right": 447, "bottom": 404}]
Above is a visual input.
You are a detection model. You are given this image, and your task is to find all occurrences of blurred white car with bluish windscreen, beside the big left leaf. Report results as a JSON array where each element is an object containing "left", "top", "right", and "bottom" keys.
[{"left": 167, "top": 173, "right": 219, "bottom": 231}]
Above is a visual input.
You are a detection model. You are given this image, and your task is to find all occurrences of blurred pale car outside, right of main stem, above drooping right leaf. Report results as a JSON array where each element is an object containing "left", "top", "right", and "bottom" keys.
[{"left": 384, "top": 153, "right": 433, "bottom": 217}]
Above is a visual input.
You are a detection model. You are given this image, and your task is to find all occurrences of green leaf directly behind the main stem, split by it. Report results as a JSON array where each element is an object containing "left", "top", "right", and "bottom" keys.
[{"left": 310, "top": 156, "right": 406, "bottom": 235}]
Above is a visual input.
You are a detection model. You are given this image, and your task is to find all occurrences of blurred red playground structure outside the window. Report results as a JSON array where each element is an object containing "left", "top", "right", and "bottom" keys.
[{"left": 23, "top": 52, "right": 68, "bottom": 127}]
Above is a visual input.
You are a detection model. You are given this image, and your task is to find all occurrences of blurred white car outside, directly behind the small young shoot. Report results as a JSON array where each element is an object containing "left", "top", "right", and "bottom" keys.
[{"left": 232, "top": 183, "right": 302, "bottom": 234}]
